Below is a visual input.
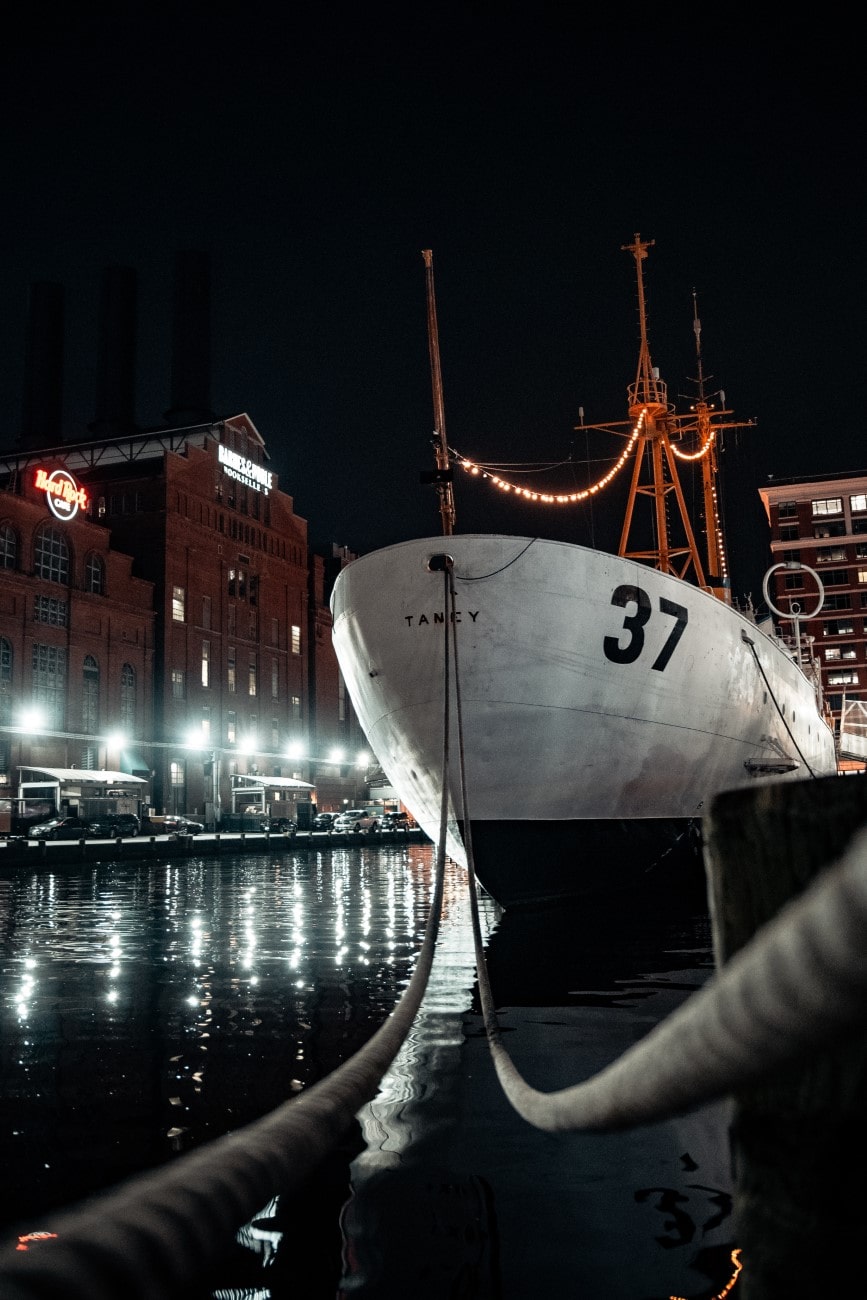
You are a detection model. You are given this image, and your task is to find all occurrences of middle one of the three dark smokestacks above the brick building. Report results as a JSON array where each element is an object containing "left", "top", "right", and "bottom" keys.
[{"left": 87, "top": 267, "right": 136, "bottom": 438}]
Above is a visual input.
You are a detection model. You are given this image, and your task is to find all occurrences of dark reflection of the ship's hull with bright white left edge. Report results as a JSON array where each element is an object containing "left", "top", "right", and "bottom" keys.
[{"left": 339, "top": 873, "right": 733, "bottom": 1300}]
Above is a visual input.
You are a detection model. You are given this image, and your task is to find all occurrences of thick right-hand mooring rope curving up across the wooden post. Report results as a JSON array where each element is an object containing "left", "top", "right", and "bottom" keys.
[{"left": 446, "top": 564, "right": 867, "bottom": 1132}]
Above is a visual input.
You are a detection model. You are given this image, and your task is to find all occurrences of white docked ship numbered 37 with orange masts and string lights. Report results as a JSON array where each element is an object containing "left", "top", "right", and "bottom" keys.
[{"left": 331, "top": 235, "right": 837, "bottom": 907}]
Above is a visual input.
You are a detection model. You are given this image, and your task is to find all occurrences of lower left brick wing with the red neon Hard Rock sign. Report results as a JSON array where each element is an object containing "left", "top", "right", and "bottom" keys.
[{"left": 0, "top": 454, "right": 155, "bottom": 788}]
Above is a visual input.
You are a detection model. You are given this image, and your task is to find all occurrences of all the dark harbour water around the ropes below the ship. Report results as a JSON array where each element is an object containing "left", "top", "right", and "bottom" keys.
[{"left": 0, "top": 846, "right": 737, "bottom": 1300}]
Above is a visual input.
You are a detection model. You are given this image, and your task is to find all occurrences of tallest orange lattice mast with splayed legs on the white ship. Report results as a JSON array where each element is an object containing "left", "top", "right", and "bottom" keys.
[{"left": 617, "top": 234, "right": 710, "bottom": 590}]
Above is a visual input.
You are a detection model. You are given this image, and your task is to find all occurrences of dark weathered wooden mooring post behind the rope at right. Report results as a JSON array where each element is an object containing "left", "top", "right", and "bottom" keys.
[{"left": 703, "top": 776, "right": 867, "bottom": 1300}]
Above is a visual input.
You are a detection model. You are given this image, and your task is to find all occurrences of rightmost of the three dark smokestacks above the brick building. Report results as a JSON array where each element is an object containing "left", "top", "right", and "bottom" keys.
[{"left": 164, "top": 245, "right": 216, "bottom": 428}]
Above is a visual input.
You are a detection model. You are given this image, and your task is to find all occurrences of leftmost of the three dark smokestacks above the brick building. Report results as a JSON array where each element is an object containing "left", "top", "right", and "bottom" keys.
[{"left": 18, "top": 281, "right": 64, "bottom": 447}]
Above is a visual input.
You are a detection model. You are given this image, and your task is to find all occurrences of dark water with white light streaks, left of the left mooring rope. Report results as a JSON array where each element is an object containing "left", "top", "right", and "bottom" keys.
[{"left": 0, "top": 846, "right": 444, "bottom": 1229}]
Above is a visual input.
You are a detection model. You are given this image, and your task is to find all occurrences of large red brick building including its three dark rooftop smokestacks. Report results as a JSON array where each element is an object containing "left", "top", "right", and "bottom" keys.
[{"left": 0, "top": 255, "right": 367, "bottom": 824}]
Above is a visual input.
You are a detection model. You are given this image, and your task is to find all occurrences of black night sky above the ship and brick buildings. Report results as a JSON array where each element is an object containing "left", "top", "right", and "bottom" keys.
[{"left": 0, "top": 10, "right": 867, "bottom": 597}]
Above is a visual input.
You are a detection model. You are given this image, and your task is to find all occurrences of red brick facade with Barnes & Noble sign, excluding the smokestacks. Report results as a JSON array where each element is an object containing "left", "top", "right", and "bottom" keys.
[{"left": 0, "top": 415, "right": 365, "bottom": 824}]
